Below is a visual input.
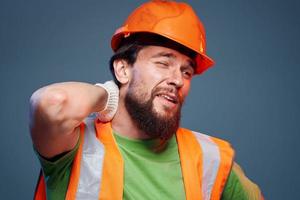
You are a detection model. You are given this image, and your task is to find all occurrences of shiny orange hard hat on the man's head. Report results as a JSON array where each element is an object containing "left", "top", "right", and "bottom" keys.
[{"left": 111, "top": 0, "right": 214, "bottom": 74}]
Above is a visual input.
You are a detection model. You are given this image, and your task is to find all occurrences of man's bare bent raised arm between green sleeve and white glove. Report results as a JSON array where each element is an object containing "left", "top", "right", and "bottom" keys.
[{"left": 30, "top": 82, "right": 108, "bottom": 158}]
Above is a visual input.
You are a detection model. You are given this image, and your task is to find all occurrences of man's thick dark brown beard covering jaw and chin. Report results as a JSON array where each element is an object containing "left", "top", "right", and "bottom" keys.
[{"left": 125, "top": 85, "right": 182, "bottom": 141}]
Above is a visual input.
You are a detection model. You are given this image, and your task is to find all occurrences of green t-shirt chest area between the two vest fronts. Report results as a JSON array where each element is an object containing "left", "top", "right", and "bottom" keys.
[{"left": 114, "top": 134, "right": 185, "bottom": 200}]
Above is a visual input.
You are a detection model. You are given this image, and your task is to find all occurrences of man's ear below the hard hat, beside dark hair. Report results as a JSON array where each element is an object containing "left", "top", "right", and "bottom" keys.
[{"left": 113, "top": 59, "right": 131, "bottom": 84}]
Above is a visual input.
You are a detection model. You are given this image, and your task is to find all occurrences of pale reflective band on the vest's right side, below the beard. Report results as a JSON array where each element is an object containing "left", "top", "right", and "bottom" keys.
[{"left": 193, "top": 131, "right": 220, "bottom": 200}]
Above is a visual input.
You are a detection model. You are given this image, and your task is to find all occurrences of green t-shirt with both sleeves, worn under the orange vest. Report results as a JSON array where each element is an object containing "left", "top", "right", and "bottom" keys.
[{"left": 37, "top": 133, "right": 260, "bottom": 200}]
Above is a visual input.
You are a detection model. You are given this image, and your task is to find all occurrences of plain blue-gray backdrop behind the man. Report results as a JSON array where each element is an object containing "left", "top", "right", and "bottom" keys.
[{"left": 0, "top": 0, "right": 300, "bottom": 199}]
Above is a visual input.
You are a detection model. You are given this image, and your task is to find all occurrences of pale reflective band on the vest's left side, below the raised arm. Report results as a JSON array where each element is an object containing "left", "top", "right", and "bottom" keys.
[{"left": 76, "top": 118, "right": 104, "bottom": 200}]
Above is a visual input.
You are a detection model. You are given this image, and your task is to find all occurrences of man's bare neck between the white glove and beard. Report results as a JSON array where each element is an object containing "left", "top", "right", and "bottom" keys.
[{"left": 112, "top": 101, "right": 149, "bottom": 139}]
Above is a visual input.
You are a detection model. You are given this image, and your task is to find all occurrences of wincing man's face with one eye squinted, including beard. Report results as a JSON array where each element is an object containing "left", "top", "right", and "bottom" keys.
[{"left": 125, "top": 46, "right": 194, "bottom": 139}]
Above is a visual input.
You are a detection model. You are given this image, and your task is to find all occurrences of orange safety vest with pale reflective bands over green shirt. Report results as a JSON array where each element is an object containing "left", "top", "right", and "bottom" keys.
[{"left": 34, "top": 119, "right": 234, "bottom": 200}]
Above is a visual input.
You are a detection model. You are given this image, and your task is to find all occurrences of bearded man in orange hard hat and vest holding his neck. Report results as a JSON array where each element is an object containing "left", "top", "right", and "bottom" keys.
[{"left": 30, "top": 1, "right": 262, "bottom": 199}]
